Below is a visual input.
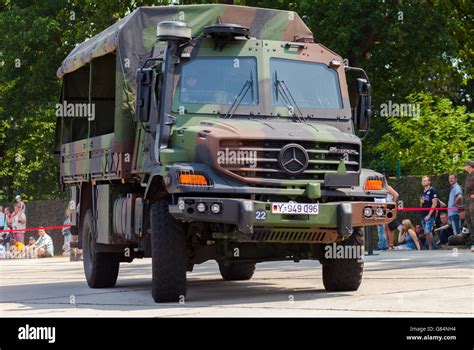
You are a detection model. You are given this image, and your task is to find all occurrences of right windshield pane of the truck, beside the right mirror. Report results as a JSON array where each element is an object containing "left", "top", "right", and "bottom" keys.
[{"left": 270, "top": 58, "right": 342, "bottom": 109}]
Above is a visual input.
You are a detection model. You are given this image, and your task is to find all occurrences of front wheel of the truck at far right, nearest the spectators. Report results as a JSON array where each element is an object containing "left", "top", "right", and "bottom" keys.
[{"left": 323, "top": 229, "right": 364, "bottom": 292}]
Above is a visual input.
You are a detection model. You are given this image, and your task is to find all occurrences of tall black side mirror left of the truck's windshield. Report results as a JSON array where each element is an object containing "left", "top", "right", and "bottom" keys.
[{"left": 135, "top": 68, "right": 155, "bottom": 123}]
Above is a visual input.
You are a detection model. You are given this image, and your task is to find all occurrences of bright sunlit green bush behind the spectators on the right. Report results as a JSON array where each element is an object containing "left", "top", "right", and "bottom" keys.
[{"left": 375, "top": 93, "right": 474, "bottom": 175}]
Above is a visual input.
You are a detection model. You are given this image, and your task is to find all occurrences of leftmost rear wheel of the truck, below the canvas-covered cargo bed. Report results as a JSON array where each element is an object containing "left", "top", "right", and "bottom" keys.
[{"left": 82, "top": 210, "right": 121, "bottom": 288}]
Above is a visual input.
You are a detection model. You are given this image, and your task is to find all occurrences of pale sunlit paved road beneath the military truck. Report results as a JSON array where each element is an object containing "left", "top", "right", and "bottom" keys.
[{"left": 0, "top": 250, "right": 474, "bottom": 317}]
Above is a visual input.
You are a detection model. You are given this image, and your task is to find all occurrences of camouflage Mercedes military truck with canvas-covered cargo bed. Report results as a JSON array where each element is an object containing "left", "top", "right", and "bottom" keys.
[{"left": 56, "top": 5, "right": 396, "bottom": 302}]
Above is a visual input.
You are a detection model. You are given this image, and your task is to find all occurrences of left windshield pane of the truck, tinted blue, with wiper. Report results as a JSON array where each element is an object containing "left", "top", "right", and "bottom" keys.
[{"left": 179, "top": 57, "right": 258, "bottom": 105}]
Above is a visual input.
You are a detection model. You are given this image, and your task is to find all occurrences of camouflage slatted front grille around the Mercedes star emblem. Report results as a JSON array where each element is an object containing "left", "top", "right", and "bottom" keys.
[{"left": 219, "top": 140, "right": 360, "bottom": 183}]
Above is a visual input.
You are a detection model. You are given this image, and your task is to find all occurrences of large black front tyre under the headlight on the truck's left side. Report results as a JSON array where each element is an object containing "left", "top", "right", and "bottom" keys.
[{"left": 150, "top": 200, "right": 187, "bottom": 302}]
